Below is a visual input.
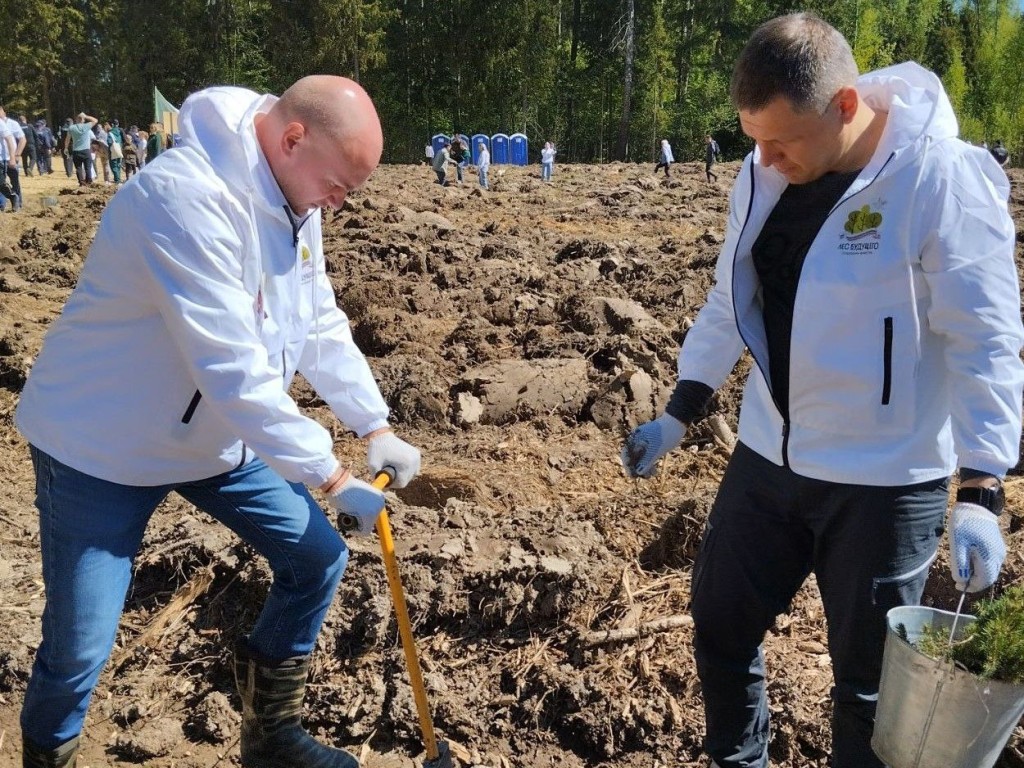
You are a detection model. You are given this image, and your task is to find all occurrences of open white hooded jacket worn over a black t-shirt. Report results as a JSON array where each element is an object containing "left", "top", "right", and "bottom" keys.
[{"left": 679, "top": 63, "right": 1024, "bottom": 485}]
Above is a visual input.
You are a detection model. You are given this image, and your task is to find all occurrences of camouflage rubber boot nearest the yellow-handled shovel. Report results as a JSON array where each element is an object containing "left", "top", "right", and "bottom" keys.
[{"left": 234, "top": 640, "right": 359, "bottom": 768}]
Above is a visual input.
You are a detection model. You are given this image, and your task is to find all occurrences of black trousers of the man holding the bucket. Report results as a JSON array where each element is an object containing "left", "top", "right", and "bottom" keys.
[{"left": 692, "top": 443, "right": 949, "bottom": 768}]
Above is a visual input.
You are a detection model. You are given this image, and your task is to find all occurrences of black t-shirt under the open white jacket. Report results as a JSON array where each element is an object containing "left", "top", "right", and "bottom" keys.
[{"left": 753, "top": 171, "right": 860, "bottom": 420}]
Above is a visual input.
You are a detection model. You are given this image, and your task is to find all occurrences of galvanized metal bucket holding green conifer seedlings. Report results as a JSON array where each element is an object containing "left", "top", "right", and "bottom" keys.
[{"left": 871, "top": 605, "right": 1024, "bottom": 768}]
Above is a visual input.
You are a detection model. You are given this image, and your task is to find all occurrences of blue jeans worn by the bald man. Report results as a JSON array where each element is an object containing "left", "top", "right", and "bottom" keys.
[{"left": 22, "top": 446, "right": 348, "bottom": 750}]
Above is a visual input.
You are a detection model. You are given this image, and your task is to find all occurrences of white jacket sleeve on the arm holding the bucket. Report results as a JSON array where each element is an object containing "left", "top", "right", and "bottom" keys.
[{"left": 922, "top": 150, "right": 1024, "bottom": 475}]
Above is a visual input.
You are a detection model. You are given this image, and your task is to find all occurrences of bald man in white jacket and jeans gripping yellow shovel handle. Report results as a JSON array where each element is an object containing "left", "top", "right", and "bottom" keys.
[{"left": 16, "top": 76, "right": 420, "bottom": 768}]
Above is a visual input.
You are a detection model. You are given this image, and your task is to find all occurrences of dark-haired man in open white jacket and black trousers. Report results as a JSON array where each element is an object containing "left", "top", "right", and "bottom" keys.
[{"left": 623, "top": 13, "right": 1024, "bottom": 768}]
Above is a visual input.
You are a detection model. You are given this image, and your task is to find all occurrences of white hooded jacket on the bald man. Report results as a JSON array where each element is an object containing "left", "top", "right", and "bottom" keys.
[{"left": 16, "top": 87, "right": 388, "bottom": 485}]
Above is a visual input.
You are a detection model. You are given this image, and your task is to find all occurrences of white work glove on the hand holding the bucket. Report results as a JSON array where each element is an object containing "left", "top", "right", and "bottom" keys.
[{"left": 949, "top": 502, "right": 1007, "bottom": 592}]
